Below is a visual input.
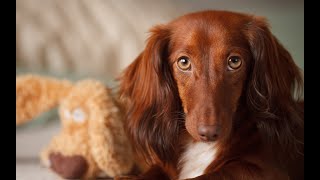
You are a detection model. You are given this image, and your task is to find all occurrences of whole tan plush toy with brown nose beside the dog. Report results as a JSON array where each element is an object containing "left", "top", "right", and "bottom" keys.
[{"left": 16, "top": 75, "right": 134, "bottom": 179}]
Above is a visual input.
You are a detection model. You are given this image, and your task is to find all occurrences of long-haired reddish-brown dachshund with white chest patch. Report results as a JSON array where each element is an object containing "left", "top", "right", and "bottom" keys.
[{"left": 119, "top": 11, "right": 304, "bottom": 180}]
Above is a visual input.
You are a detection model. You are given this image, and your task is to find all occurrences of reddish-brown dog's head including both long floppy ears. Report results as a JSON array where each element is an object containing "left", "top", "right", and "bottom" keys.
[{"left": 120, "top": 11, "right": 301, "bottom": 163}]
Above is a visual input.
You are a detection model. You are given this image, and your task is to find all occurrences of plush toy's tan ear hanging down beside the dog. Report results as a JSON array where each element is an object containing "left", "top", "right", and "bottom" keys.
[{"left": 88, "top": 83, "right": 134, "bottom": 177}]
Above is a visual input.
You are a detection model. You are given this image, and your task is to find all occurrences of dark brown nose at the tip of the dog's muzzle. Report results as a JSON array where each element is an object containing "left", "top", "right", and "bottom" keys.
[{"left": 198, "top": 125, "right": 220, "bottom": 141}]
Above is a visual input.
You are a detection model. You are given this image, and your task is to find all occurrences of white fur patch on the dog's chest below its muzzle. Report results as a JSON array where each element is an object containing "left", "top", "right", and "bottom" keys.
[{"left": 179, "top": 142, "right": 216, "bottom": 179}]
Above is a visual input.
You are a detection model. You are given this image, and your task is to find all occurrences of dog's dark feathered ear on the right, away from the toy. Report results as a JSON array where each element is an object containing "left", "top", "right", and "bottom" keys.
[{"left": 245, "top": 17, "right": 303, "bottom": 153}]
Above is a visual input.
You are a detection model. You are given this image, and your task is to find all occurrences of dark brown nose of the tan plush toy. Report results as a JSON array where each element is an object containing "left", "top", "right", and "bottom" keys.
[{"left": 49, "top": 153, "right": 88, "bottom": 179}]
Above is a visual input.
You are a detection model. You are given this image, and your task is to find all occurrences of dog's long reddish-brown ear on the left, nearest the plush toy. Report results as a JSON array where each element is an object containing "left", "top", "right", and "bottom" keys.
[{"left": 120, "top": 25, "right": 181, "bottom": 164}]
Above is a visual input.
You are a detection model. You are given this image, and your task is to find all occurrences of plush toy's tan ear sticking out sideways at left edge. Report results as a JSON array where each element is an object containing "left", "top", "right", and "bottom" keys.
[{"left": 16, "top": 75, "right": 72, "bottom": 125}]
